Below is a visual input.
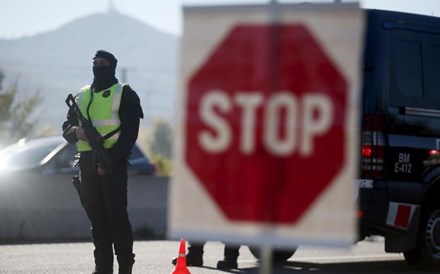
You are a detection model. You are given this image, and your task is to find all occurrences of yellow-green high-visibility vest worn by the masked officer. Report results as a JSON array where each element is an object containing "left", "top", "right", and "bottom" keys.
[{"left": 75, "top": 83, "right": 124, "bottom": 152}]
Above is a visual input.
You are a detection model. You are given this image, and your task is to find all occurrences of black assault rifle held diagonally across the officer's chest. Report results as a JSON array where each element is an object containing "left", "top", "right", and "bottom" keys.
[{"left": 66, "top": 94, "right": 112, "bottom": 175}]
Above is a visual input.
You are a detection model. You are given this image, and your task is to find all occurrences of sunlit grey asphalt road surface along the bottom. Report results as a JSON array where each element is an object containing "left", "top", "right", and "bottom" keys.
[{"left": 0, "top": 240, "right": 438, "bottom": 274}]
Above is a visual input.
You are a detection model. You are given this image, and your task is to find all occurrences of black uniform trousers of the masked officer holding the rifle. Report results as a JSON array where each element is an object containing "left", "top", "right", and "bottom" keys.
[{"left": 79, "top": 152, "right": 133, "bottom": 271}]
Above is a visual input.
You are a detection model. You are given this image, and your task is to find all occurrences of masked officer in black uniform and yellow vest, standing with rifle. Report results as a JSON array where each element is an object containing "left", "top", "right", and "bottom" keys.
[{"left": 62, "top": 50, "right": 143, "bottom": 274}]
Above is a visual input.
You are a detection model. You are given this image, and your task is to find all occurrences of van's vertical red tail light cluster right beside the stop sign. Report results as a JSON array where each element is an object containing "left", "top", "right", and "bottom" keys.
[{"left": 361, "top": 115, "right": 386, "bottom": 178}]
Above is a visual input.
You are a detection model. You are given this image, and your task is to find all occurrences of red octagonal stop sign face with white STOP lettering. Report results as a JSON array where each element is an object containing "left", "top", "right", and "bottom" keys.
[{"left": 184, "top": 24, "right": 348, "bottom": 224}]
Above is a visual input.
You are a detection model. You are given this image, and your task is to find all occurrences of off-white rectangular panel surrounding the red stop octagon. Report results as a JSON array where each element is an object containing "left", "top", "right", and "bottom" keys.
[{"left": 168, "top": 4, "right": 363, "bottom": 247}]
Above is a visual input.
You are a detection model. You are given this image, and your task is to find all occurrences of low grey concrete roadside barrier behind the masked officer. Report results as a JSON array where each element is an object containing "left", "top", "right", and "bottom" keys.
[{"left": 0, "top": 176, "right": 169, "bottom": 243}]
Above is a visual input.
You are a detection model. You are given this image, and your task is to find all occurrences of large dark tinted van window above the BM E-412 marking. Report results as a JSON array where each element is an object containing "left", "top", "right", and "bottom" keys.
[{"left": 389, "top": 26, "right": 440, "bottom": 110}]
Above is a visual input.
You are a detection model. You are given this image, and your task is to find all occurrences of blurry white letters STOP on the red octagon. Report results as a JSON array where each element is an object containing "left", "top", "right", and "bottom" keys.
[{"left": 198, "top": 90, "right": 333, "bottom": 157}]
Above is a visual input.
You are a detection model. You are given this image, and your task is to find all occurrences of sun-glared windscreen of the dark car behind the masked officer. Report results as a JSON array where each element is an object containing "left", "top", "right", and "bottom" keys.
[{"left": 0, "top": 142, "right": 60, "bottom": 170}]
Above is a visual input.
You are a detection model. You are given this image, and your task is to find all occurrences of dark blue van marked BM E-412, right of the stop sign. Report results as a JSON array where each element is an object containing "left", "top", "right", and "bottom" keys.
[{"left": 359, "top": 10, "right": 440, "bottom": 268}]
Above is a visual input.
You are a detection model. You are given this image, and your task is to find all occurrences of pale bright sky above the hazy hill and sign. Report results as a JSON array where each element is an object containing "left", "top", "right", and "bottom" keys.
[{"left": 0, "top": 0, "right": 440, "bottom": 39}]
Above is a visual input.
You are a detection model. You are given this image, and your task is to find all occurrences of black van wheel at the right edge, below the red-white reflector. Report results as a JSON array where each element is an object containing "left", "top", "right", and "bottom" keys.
[{"left": 403, "top": 208, "right": 440, "bottom": 269}]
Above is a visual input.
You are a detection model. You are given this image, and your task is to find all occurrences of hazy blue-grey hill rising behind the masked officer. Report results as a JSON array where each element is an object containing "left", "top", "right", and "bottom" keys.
[{"left": 0, "top": 10, "right": 179, "bottom": 133}]
